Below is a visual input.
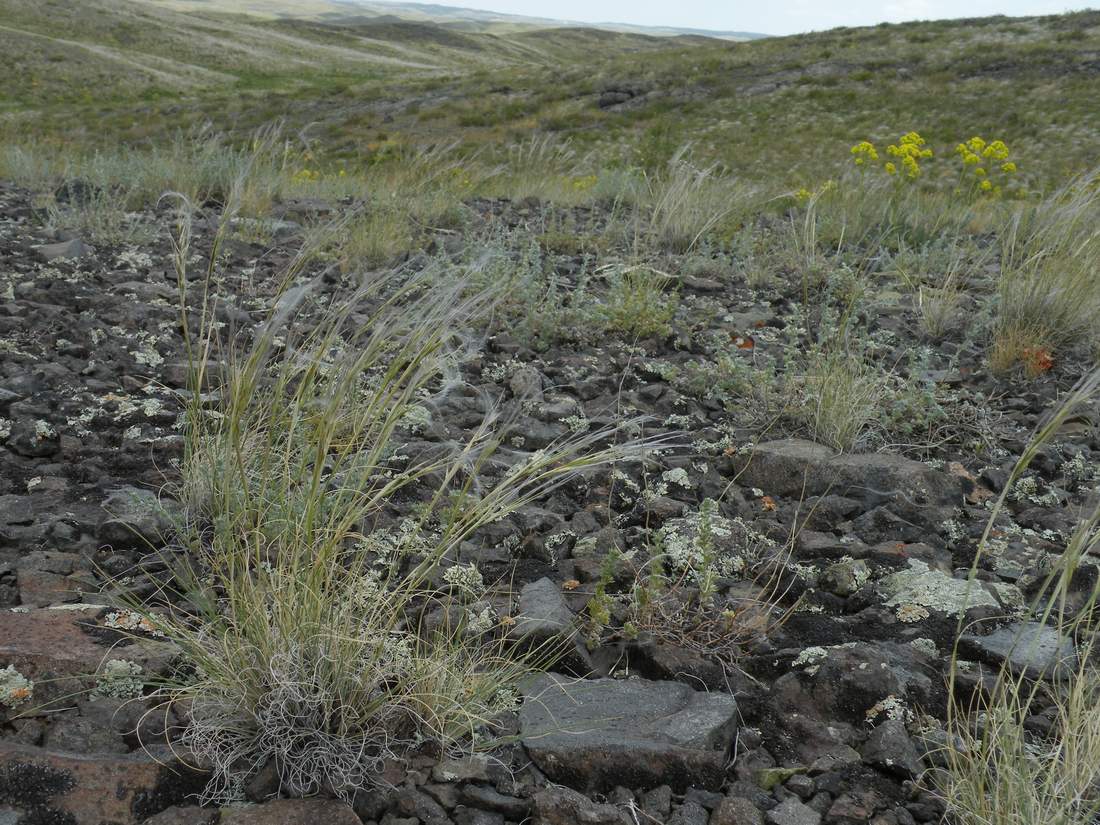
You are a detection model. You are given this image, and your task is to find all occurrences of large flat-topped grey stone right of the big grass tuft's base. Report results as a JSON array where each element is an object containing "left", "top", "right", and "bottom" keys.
[{"left": 519, "top": 674, "right": 737, "bottom": 791}]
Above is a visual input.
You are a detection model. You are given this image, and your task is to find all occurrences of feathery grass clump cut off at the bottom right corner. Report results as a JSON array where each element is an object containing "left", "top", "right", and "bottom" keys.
[{"left": 927, "top": 371, "right": 1100, "bottom": 825}]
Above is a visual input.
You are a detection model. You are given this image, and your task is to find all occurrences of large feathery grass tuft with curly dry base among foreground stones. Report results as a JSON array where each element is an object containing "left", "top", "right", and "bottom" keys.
[{"left": 142, "top": 182, "right": 646, "bottom": 802}]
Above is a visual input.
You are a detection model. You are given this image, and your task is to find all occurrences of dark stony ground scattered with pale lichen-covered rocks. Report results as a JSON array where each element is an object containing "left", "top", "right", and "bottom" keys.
[{"left": 0, "top": 186, "right": 1100, "bottom": 825}]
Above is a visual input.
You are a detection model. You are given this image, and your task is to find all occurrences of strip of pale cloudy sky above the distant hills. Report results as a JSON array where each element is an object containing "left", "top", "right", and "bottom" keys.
[{"left": 418, "top": 0, "right": 1097, "bottom": 34}]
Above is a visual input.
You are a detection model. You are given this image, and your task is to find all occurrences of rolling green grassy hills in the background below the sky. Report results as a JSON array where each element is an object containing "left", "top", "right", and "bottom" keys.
[{"left": 0, "top": 0, "right": 1100, "bottom": 186}]
